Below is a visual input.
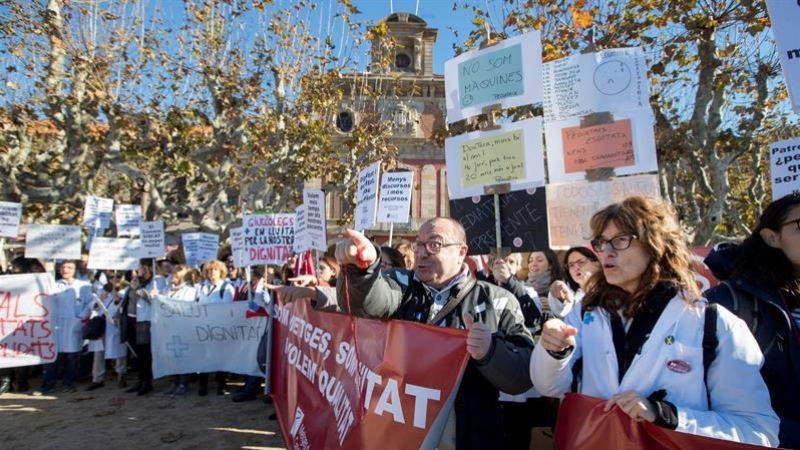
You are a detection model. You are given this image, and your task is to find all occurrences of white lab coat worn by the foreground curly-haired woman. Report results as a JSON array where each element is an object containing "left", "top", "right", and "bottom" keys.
[{"left": 530, "top": 296, "right": 779, "bottom": 447}]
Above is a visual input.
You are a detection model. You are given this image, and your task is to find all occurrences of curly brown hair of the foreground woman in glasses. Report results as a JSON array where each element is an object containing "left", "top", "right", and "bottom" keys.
[{"left": 583, "top": 197, "right": 700, "bottom": 317}]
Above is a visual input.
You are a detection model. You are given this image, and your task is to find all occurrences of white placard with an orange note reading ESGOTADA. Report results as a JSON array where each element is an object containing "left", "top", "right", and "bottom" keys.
[{"left": 544, "top": 111, "right": 658, "bottom": 183}]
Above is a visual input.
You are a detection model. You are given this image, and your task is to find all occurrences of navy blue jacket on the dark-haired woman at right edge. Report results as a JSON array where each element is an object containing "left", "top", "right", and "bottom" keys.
[{"left": 704, "top": 245, "right": 800, "bottom": 449}]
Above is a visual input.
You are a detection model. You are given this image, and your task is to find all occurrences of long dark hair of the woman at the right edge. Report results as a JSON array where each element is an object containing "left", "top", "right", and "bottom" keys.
[{"left": 732, "top": 192, "right": 800, "bottom": 297}]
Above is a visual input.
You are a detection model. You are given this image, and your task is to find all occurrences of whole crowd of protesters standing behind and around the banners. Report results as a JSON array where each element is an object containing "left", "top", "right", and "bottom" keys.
[{"left": 0, "top": 193, "right": 800, "bottom": 449}]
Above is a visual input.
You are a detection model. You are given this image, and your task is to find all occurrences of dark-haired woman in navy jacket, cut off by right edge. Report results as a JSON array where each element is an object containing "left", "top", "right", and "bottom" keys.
[{"left": 705, "top": 192, "right": 800, "bottom": 449}]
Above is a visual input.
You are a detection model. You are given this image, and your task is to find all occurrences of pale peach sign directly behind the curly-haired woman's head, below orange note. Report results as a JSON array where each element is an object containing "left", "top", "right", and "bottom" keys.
[{"left": 547, "top": 175, "right": 660, "bottom": 247}]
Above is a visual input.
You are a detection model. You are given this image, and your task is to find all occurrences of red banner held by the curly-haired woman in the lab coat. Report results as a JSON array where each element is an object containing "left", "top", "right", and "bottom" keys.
[{"left": 555, "top": 394, "right": 764, "bottom": 450}]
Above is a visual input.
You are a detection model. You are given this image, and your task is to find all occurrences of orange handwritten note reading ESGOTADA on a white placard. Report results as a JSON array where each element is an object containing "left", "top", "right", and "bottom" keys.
[{"left": 561, "top": 119, "right": 635, "bottom": 173}]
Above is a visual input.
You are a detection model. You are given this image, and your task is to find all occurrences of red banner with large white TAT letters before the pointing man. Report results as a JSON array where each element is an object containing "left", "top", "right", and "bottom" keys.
[{"left": 271, "top": 301, "right": 468, "bottom": 450}]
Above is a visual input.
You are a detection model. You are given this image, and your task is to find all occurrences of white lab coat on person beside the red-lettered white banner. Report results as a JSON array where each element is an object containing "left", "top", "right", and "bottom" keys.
[{"left": 54, "top": 279, "right": 92, "bottom": 353}]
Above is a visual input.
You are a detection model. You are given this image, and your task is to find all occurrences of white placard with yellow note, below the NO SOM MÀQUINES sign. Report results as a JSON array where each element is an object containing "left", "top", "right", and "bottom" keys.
[{"left": 444, "top": 117, "right": 545, "bottom": 199}]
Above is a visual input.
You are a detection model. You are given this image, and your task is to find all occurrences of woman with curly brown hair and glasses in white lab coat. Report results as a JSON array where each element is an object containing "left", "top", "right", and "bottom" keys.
[{"left": 530, "top": 197, "right": 778, "bottom": 446}]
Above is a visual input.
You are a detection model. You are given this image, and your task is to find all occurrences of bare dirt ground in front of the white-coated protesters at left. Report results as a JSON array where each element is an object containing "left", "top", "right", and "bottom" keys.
[{"left": 0, "top": 374, "right": 286, "bottom": 450}]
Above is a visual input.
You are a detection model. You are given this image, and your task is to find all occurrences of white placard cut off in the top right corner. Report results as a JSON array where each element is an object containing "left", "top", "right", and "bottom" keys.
[{"left": 767, "top": 0, "right": 800, "bottom": 115}]
